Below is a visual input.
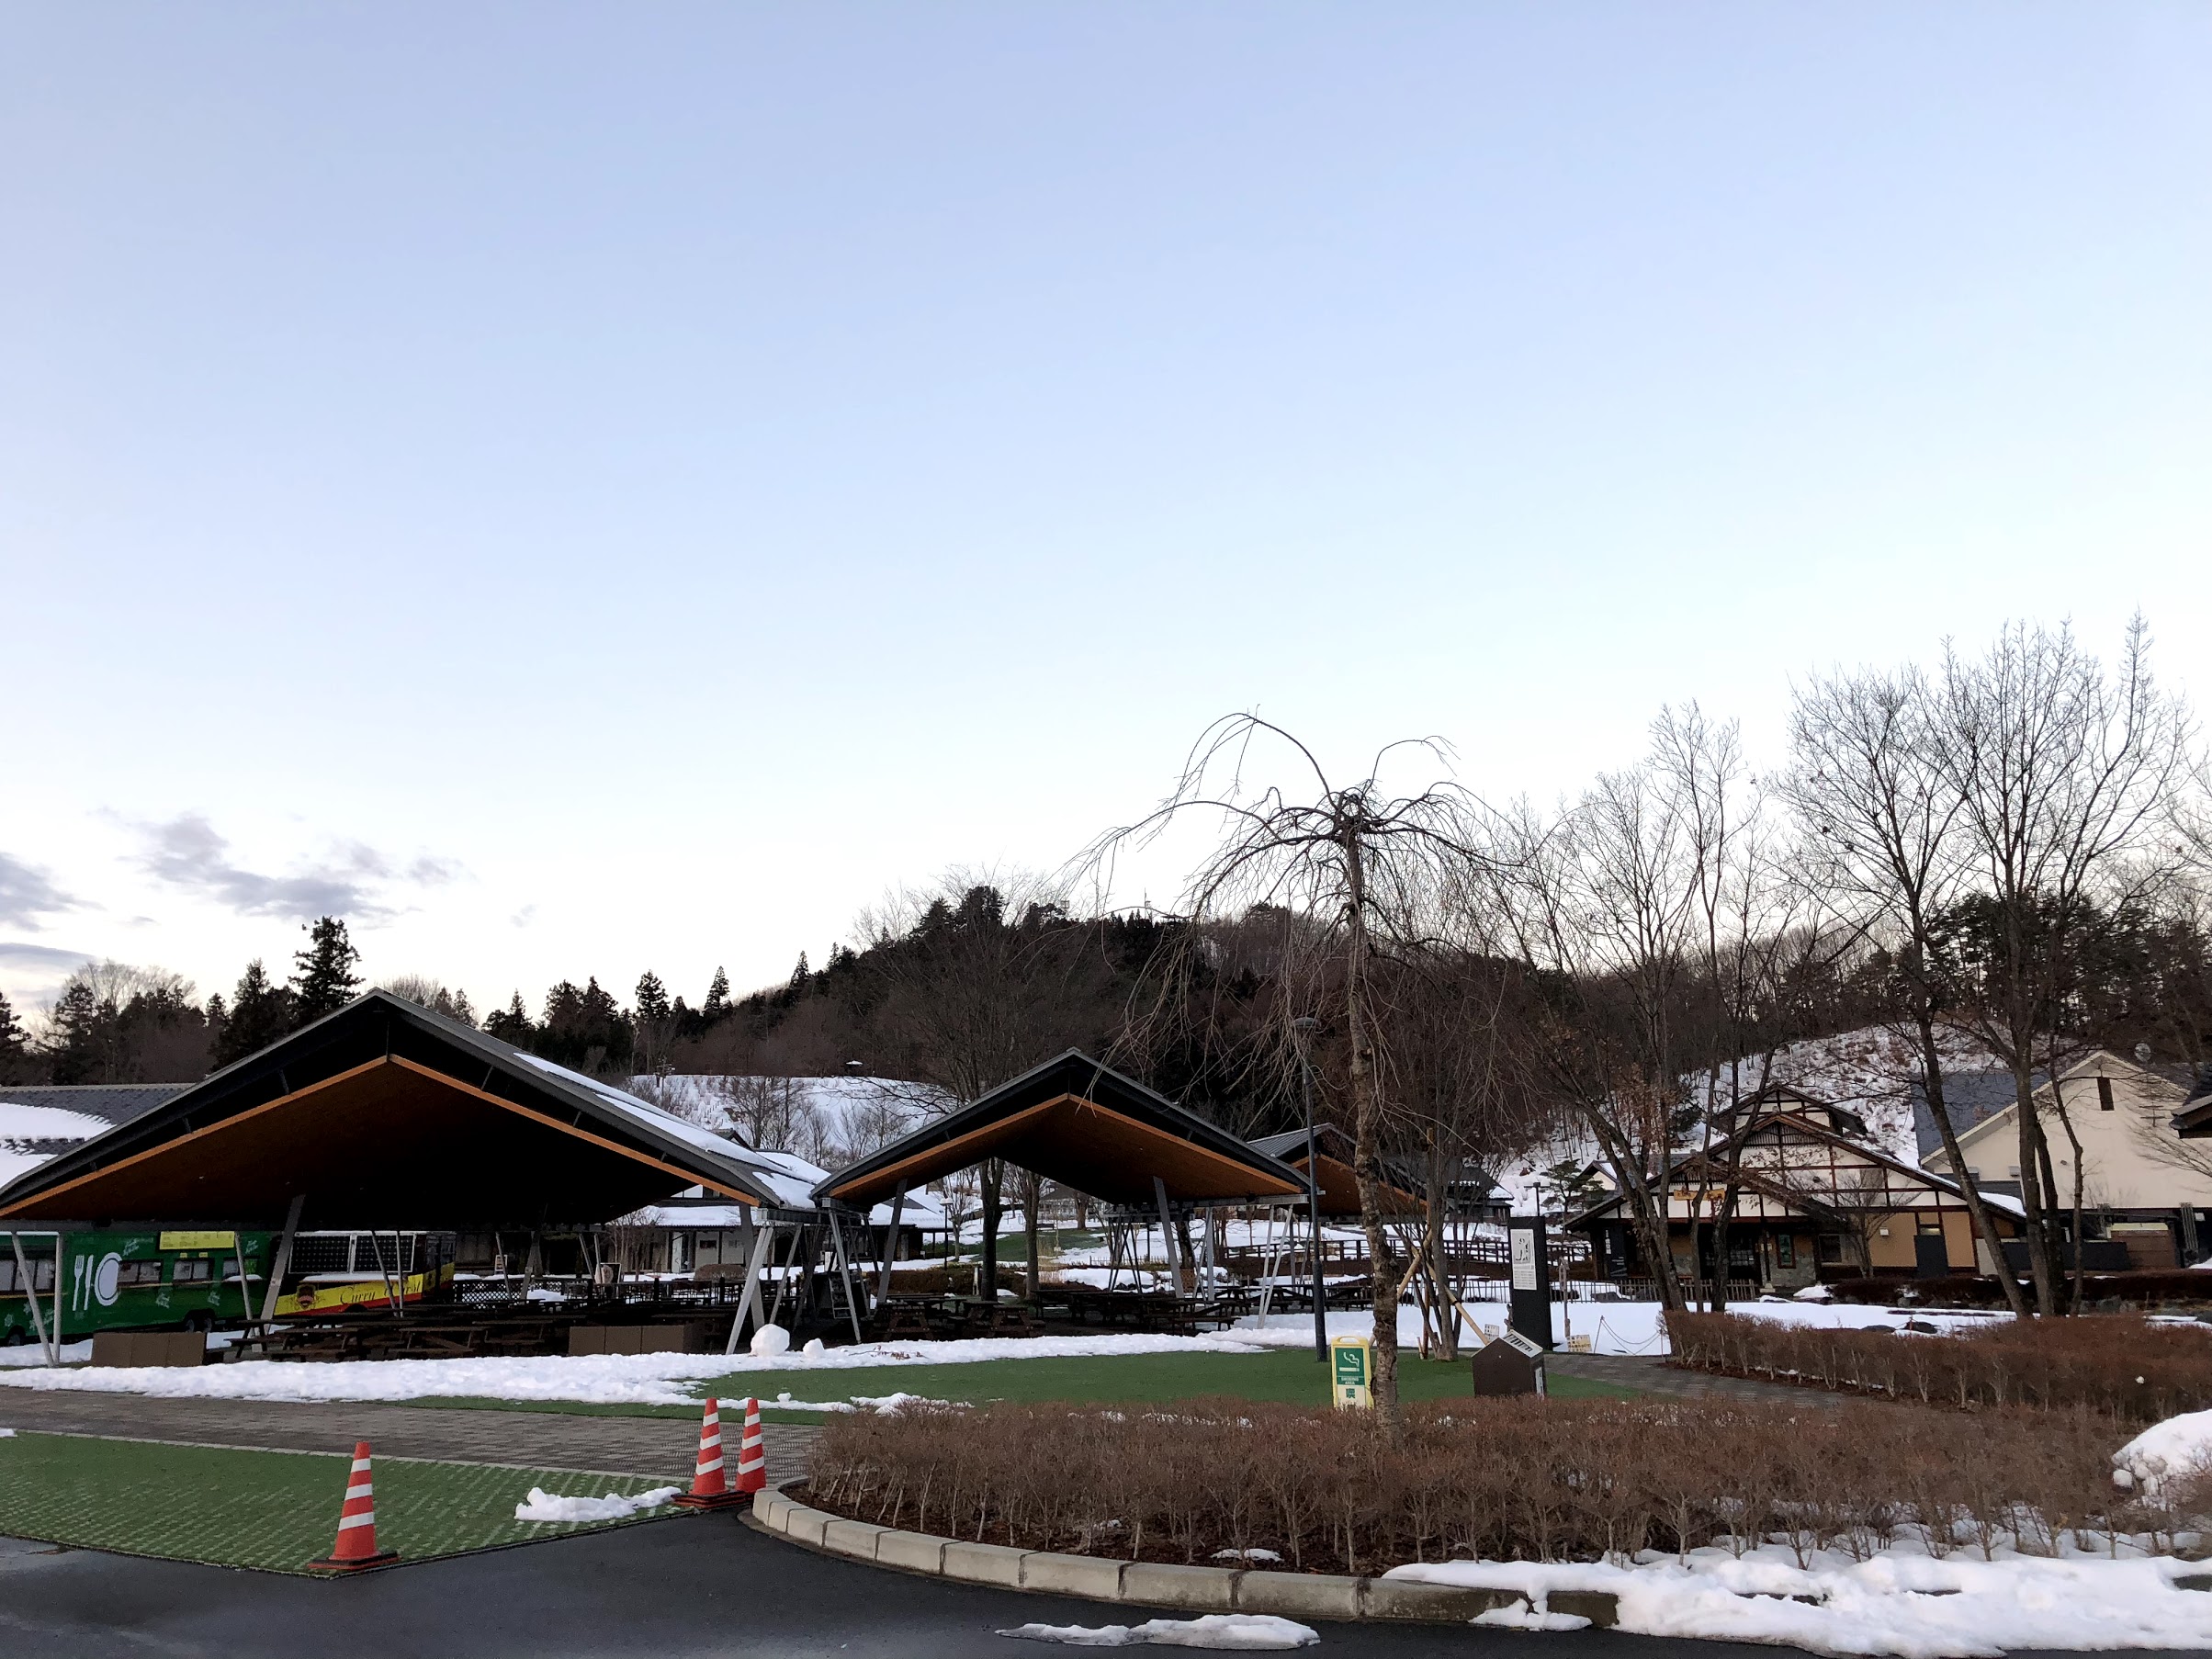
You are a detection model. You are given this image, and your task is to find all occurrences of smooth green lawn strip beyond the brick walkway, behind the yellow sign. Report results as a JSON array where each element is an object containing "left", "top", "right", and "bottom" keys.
[{"left": 418, "top": 1347, "right": 1635, "bottom": 1422}]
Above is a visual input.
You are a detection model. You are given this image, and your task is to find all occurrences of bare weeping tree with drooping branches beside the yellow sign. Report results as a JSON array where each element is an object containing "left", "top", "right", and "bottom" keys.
[{"left": 1084, "top": 715, "right": 1482, "bottom": 1438}]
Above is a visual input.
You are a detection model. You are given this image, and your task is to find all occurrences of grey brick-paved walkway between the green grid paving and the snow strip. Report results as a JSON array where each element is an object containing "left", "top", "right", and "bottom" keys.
[{"left": 0, "top": 1389, "right": 814, "bottom": 1482}]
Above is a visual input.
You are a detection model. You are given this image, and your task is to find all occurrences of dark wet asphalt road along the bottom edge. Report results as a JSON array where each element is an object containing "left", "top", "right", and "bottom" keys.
[{"left": 0, "top": 1513, "right": 1823, "bottom": 1659}]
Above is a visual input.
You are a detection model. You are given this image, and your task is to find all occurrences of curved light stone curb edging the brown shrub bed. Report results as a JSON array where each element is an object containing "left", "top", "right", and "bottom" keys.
[{"left": 752, "top": 1489, "right": 1617, "bottom": 1626}]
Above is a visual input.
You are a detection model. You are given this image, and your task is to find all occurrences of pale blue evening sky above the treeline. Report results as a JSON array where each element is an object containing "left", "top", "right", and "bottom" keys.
[{"left": 0, "top": 0, "right": 2212, "bottom": 1026}]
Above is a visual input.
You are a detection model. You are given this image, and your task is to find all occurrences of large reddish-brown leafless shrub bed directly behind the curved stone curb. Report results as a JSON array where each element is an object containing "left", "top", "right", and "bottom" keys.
[{"left": 809, "top": 1400, "right": 2195, "bottom": 1573}]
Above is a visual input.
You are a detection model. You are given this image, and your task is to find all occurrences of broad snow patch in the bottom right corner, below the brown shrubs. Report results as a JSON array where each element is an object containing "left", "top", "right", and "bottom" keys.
[{"left": 1384, "top": 1540, "right": 2212, "bottom": 1659}]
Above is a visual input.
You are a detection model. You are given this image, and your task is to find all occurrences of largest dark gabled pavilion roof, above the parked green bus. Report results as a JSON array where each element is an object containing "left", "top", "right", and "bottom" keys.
[{"left": 0, "top": 991, "right": 806, "bottom": 1224}]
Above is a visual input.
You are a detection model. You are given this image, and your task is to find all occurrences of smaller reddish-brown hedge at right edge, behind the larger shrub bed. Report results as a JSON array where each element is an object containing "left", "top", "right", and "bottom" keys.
[{"left": 1665, "top": 1314, "right": 2212, "bottom": 1422}]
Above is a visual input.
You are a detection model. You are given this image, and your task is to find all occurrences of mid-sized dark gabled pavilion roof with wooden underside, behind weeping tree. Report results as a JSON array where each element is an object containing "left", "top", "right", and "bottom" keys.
[{"left": 814, "top": 1048, "right": 1305, "bottom": 1205}]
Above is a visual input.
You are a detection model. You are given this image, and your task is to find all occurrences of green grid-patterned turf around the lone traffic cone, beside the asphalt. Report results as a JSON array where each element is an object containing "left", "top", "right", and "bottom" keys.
[{"left": 0, "top": 1431, "right": 671, "bottom": 1573}]
